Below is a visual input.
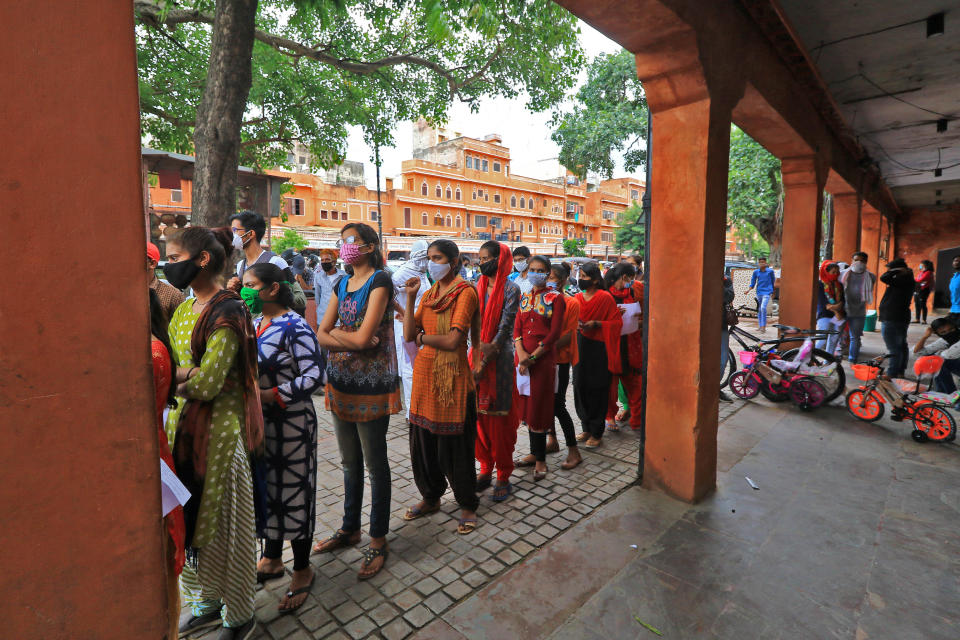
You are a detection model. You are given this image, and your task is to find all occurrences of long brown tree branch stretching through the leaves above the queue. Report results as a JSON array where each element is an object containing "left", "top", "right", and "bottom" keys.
[{"left": 133, "top": 0, "right": 503, "bottom": 97}]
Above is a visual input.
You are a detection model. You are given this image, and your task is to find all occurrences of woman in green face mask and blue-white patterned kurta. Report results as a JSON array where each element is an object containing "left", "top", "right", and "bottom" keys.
[{"left": 240, "top": 263, "right": 323, "bottom": 612}]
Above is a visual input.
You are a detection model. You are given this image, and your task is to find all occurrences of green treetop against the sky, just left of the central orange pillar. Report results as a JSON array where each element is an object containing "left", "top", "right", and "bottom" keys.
[{"left": 551, "top": 51, "right": 647, "bottom": 178}]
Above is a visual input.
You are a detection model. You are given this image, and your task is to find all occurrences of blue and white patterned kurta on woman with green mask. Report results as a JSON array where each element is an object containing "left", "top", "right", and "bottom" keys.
[{"left": 254, "top": 311, "right": 324, "bottom": 540}]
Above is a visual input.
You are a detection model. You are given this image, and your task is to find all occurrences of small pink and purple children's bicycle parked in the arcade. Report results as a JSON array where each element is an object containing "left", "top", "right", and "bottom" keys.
[{"left": 730, "top": 340, "right": 828, "bottom": 411}]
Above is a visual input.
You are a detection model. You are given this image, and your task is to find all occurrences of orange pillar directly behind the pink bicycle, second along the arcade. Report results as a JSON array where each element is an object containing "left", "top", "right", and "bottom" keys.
[{"left": 780, "top": 156, "right": 826, "bottom": 329}]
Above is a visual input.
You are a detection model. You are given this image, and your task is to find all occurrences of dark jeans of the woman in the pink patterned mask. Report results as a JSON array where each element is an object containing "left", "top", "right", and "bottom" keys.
[{"left": 331, "top": 414, "right": 391, "bottom": 538}]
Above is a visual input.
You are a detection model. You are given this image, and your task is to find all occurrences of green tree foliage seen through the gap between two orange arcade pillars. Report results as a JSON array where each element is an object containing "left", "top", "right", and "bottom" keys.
[{"left": 727, "top": 127, "right": 783, "bottom": 259}]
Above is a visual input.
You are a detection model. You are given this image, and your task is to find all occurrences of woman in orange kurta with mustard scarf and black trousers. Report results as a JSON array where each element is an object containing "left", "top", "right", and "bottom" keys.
[{"left": 403, "top": 240, "right": 481, "bottom": 535}]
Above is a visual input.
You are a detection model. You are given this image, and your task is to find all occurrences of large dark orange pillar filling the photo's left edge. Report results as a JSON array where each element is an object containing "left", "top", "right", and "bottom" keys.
[{"left": 0, "top": 0, "right": 166, "bottom": 640}]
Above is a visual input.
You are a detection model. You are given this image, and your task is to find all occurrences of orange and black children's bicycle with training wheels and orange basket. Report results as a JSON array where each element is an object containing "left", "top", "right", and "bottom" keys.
[{"left": 847, "top": 354, "right": 957, "bottom": 442}]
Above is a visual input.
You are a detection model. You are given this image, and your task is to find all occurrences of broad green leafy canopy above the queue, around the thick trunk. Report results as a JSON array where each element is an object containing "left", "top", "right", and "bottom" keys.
[{"left": 134, "top": 0, "right": 582, "bottom": 169}]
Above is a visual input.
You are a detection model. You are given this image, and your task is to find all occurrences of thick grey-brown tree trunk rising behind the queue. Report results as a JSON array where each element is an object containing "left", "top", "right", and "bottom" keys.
[{"left": 191, "top": 0, "right": 258, "bottom": 227}]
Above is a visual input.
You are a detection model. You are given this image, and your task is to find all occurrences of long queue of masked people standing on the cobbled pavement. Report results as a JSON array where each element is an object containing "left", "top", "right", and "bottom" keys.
[{"left": 147, "top": 212, "right": 643, "bottom": 640}]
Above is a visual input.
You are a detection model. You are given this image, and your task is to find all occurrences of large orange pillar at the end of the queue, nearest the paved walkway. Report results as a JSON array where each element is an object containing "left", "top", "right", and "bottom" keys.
[{"left": 643, "top": 83, "right": 730, "bottom": 501}]
